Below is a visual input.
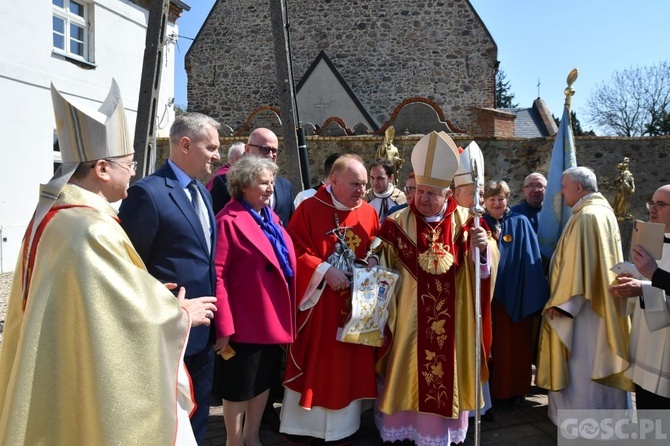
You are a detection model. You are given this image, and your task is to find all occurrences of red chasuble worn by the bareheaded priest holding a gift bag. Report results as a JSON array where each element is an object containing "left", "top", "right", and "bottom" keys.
[{"left": 284, "top": 188, "right": 379, "bottom": 410}]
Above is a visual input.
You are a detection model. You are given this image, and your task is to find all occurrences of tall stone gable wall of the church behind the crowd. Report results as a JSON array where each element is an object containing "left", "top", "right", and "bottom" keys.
[{"left": 186, "top": 0, "right": 498, "bottom": 134}]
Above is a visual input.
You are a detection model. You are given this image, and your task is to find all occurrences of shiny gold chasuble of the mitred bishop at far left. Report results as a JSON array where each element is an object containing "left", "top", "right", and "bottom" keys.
[{"left": 0, "top": 184, "right": 193, "bottom": 446}]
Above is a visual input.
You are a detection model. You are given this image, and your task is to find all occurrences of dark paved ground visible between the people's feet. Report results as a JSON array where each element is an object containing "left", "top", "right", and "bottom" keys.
[{"left": 205, "top": 387, "right": 556, "bottom": 446}]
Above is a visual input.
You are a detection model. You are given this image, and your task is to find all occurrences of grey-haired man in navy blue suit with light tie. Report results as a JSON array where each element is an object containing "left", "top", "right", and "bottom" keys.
[{"left": 119, "top": 113, "right": 220, "bottom": 444}]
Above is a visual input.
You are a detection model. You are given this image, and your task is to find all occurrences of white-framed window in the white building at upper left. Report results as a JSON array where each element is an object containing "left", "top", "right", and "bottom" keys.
[{"left": 51, "top": 0, "right": 90, "bottom": 61}]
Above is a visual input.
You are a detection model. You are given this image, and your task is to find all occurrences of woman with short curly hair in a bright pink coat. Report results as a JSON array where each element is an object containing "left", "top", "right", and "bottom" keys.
[{"left": 214, "top": 155, "right": 296, "bottom": 446}]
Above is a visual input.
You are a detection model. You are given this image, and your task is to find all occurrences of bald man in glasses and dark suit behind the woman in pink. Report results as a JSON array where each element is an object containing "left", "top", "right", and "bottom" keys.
[{"left": 211, "top": 127, "right": 295, "bottom": 226}]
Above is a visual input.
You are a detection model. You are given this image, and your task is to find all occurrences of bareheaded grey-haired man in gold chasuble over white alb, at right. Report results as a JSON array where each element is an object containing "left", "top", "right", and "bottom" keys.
[{"left": 536, "top": 167, "right": 633, "bottom": 424}]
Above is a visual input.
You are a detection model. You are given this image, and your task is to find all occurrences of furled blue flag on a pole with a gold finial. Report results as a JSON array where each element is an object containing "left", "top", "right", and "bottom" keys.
[{"left": 537, "top": 99, "right": 577, "bottom": 258}]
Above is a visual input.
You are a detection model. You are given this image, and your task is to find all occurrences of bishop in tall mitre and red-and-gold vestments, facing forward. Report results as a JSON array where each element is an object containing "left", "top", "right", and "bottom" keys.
[{"left": 374, "top": 132, "right": 498, "bottom": 446}]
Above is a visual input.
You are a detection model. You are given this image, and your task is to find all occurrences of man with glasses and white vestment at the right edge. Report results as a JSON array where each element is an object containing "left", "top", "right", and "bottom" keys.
[{"left": 610, "top": 184, "right": 670, "bottom": 410}]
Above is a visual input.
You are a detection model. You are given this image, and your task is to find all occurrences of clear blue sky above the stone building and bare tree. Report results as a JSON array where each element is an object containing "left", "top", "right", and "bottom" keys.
[{"left": 175, "top": 0, "right": 670, "bottom": 134}]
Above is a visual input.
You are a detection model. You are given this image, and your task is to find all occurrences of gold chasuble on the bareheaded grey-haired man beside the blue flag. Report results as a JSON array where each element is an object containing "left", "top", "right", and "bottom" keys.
[{"left": 536, "top": 192, "right": 634, "bottom": 391}]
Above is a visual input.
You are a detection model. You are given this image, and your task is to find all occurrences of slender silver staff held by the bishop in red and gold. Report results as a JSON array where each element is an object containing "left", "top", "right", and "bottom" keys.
[{"left": 470, "top": 158, "right": 484, "bottom": 446}]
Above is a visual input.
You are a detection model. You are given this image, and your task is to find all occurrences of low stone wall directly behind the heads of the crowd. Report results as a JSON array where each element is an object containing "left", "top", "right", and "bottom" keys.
[{"left": 158, "top": 135, "right": 670, "bottom": 226}]
